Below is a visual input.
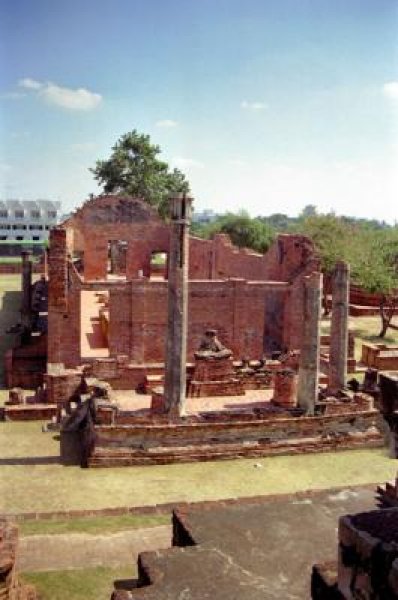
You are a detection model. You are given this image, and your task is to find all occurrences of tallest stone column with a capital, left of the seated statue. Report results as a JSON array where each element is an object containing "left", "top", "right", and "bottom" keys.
[{"left": 165, "top": 194, "right": 192, "bottom": 417}]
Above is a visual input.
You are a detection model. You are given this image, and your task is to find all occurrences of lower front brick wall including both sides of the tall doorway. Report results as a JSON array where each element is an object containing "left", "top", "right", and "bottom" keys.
[{"left": 48, "top": 266, "right": 308, "bottom": 368}]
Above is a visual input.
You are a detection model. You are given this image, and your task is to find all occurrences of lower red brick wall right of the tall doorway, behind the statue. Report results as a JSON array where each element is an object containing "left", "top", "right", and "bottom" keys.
[{"left": 109, "top": 279, "right": 289, "bottom": 363}]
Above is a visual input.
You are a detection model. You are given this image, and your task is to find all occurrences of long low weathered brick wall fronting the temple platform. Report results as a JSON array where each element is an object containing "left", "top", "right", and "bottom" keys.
[{"left": 89, "top": 410, "right": 384, "bottom": 466}]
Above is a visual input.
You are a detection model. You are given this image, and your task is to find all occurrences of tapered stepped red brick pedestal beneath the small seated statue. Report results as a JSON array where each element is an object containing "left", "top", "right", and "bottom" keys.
[{"left": 188, "top": 357, "right": 244, "bottom": 398}]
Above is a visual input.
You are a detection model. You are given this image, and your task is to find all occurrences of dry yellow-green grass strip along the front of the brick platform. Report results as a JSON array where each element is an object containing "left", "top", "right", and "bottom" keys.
[{"left": 0, "top": 422, "right": 397, "bottom": 513}]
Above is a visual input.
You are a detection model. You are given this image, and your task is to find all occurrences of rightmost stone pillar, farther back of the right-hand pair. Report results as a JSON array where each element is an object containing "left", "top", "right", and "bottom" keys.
[{"left": 328, "top": 261, "right": 350, "bottom": 393}]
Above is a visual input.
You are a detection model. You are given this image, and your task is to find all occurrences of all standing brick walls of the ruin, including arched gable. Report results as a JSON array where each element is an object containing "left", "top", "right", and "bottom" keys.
[{"left": 48, "top": 196, "right": 319, "bottom": 380}]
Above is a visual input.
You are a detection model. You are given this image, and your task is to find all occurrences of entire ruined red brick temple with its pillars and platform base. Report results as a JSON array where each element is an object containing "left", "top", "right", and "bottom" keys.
[{"left": 37, "top": 195, "right": 383, "bottom": 467}]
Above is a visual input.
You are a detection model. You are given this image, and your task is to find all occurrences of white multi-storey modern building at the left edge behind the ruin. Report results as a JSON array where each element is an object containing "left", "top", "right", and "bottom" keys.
[{"left": 0, "top": 200, "right": 61, "bottom": 242}]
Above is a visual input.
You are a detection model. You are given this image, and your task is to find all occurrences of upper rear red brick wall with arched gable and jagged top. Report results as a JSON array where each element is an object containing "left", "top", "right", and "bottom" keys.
[{"left": 65, "top": 196, "right": 314, "bottom": 281}]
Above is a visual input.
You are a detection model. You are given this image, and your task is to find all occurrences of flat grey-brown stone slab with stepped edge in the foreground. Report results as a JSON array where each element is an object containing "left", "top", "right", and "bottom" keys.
[{"left": 121, "top": 488, "right": 380, "bottom": 600}]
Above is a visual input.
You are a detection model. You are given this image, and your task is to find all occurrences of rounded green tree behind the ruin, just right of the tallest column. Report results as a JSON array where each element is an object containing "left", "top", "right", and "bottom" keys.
[{"left": 197, "top": 210, "right": 275, "bottom": 253}]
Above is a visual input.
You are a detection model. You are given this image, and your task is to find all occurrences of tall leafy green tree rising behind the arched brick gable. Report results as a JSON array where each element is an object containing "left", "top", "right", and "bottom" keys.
[{"left": 90, "top": 129, "right": 189, "bottom": 215}]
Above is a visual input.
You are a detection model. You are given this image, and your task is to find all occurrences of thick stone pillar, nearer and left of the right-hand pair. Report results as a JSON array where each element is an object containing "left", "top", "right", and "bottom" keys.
[{"left": 297, "top": 272, "right": 322, "bottom": 415}]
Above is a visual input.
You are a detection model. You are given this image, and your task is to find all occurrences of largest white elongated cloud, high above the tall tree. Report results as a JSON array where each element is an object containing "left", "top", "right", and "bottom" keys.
[{"left": 18, "top": 77, "right": 102, "bottom": 111}]
